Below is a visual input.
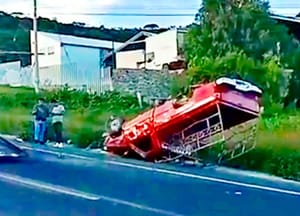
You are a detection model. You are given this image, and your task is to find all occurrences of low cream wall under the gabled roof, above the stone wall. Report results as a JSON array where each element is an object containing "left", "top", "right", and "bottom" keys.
[{"left": 116, "top": 50, "right": 145, "bottom": 69}]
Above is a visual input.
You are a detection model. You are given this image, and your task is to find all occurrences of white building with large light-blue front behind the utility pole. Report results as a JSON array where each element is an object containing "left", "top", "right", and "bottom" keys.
[{"left": 30, "top": 31, "right": 122, "bottom": 90}]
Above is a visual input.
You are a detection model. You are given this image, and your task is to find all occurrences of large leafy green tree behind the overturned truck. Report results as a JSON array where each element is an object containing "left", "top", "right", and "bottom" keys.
[{"left": 185, "top": 0, "right": 300, "bottom": 107}]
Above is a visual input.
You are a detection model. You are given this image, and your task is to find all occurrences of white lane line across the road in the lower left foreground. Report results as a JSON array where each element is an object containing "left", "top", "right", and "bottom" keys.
[{"left": 0, "top": 173, "right": 183, "bottom": 216}]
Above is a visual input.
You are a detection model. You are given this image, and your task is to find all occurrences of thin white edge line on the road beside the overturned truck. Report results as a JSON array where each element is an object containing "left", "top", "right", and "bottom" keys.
[{"left": 105, "top": 161, "right": 300, "bottom": 196}]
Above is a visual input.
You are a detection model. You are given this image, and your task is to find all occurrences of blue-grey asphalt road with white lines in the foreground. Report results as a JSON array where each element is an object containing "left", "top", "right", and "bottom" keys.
[{"left": 0, "top": 145, "right": 300, "bottom": 216}]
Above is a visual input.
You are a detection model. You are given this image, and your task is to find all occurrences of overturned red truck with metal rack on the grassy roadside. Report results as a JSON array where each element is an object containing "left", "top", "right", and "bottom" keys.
[{"left": 104, "top": 77, "right": 263, "bottom": 162}]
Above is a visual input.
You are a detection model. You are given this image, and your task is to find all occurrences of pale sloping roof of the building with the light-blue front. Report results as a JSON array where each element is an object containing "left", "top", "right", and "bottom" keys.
[{"left": 38, "top": 32, "right": 123, "bottom": 49}]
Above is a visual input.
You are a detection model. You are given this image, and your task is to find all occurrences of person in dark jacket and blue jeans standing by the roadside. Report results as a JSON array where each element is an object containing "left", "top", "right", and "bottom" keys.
[{"left": 32, "top": 98, "right": 49, "bottom": 145}]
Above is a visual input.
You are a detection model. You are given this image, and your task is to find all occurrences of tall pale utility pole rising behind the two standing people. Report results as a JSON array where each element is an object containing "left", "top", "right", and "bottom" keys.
[{"left": 33, "top": 0, "right": 40, "bottom": 93}]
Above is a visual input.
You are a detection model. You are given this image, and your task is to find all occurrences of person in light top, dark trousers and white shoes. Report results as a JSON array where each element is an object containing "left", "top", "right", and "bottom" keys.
[{"left": 51, "top": 100, "right": 65, "bottom": 147}]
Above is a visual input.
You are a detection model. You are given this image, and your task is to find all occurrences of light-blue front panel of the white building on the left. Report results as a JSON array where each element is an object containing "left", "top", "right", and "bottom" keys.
[{"left": 61, "top": 45, "right": 109, "bottom": 89}]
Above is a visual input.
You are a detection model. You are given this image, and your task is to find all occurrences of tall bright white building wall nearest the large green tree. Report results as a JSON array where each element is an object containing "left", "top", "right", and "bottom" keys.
[{"left": 146, "top": 29, "right": 178, "bottom": 70}]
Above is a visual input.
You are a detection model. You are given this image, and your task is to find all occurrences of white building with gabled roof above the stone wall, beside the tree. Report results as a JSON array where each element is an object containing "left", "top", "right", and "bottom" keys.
[{"left": 105, "top": 29, "right": 186, "bottom": 70}]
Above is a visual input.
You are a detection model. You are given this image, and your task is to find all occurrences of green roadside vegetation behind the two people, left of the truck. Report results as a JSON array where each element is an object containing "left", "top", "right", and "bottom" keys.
[{"left": 0, "top": 86, "right": 147, "bottom": 147}]
